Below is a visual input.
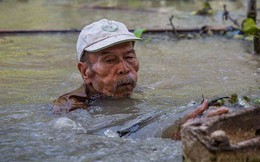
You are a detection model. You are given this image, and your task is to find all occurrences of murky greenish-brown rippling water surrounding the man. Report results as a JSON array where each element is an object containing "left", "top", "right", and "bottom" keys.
[{"left": 0, "top": 0, "right": 260, "bottom": 161}]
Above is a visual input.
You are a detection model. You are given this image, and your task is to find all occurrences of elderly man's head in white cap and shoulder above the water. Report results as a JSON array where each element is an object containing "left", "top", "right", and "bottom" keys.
[{"left": 53, "top": 19, "right": 140, "bottom": 113}]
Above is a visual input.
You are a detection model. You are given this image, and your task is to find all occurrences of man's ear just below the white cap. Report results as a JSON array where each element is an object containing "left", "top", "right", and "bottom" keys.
[{"left": 77, "top": 62, "right": 92, "bottom": 84}]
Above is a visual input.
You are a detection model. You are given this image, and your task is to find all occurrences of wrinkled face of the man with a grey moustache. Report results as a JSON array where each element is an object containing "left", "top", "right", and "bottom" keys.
[{"left": 85, "top": 42, "right": 139, "bottom": 98}]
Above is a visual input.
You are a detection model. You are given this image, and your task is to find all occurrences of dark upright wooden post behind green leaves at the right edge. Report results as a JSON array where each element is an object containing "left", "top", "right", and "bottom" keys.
[{"left": 247, "top": 0, "right": 260, "bottom": 55}]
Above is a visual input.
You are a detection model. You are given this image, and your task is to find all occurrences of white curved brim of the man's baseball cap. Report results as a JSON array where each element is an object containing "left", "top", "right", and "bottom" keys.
[{"left": 84, "top": 35, "right": 141, "bottom": 52}]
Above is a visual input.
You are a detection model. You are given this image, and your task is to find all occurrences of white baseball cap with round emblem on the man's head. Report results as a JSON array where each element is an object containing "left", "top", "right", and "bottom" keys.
[{"left": 77, "top": 19, "right": 140, "bottom": 61}]
